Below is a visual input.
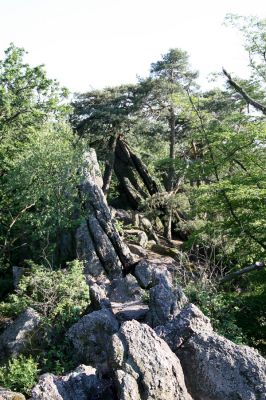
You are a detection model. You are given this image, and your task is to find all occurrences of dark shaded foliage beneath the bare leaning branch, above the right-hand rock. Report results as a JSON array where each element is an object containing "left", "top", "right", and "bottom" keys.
[{"left": 184, "top": 270, "right": 266, "bottom": 355}]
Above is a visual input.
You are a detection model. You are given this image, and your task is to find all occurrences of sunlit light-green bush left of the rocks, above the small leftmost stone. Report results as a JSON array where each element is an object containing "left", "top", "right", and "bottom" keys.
[{"left": 1, "top": 260, "right": 89, "bottom": 326}]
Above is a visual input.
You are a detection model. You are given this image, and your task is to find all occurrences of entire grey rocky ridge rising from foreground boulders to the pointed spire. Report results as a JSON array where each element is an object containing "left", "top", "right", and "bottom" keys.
[{"left": 0, "top": 151, "right": 266, "bottom": 400}]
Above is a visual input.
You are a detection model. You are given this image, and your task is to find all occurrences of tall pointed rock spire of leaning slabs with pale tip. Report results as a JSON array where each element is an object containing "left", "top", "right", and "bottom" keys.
[{"left": 76, "top": 149, "right": 134, "bottom": 278}]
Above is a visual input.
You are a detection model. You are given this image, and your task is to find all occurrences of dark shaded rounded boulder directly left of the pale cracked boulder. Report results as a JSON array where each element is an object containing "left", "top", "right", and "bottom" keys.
[{"left": 67, "top": 309, "right": 119, "bottom": 366}]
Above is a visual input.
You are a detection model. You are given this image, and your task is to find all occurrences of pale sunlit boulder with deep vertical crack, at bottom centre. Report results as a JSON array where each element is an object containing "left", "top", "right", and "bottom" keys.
[{"left": 110, "top": 321, "right": 191, "bottom": 400}]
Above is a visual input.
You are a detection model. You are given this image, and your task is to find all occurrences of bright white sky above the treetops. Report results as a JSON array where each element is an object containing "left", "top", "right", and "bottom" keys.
[{"left": 0, "top": 0, "right": 266, "bottom": 92}]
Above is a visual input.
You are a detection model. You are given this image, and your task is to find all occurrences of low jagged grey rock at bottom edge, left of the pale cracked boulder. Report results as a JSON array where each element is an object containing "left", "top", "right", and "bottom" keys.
[{"left": 30, "top": 365, "right": 115, "bottom": 400}]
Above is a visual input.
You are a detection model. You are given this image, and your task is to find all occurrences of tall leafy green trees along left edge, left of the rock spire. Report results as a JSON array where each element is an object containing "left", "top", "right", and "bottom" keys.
[{"left": 0, "top": 45, "right": 80, "bottom": 270}]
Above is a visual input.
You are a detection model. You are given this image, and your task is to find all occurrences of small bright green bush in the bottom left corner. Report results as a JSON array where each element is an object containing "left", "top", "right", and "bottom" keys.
[{"left": 0, "top": 355, "right": 39, "bottom": 395}]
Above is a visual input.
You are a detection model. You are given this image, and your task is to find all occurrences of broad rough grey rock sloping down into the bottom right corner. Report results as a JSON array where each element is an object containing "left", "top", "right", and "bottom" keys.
[{"left": 156, "top": 304, "right": 266, "bottom": 400}]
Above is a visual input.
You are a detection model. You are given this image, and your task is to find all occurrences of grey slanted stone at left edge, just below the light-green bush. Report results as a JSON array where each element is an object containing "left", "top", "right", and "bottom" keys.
[{"left": 0, "top": 308, "right": 41, "bottom": 359}]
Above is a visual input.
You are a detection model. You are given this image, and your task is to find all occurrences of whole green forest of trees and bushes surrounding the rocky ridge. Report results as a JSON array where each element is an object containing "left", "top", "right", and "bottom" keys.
[{"left": 0, "top": 15, "right": 266, "bottom": 398}]
